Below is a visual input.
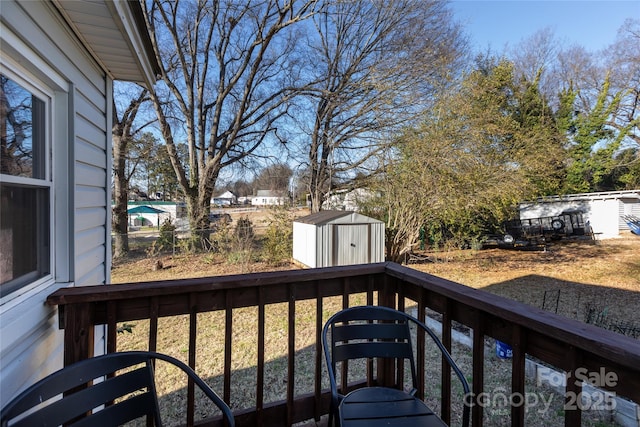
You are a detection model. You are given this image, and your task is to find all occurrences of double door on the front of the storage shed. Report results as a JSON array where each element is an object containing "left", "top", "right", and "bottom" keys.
[{"left": 333, "top": 224, "right": 371, "bottom": 265}]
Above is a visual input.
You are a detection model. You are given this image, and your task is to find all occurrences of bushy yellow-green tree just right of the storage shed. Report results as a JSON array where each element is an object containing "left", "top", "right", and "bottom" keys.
[{"left": 368, "top": 58, "right": 564, "bottom": 261}]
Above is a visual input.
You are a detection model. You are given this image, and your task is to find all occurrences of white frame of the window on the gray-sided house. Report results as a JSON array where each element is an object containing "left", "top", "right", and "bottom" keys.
[{"left": 0, "top": 52, "right": 68, "bottom": 313}]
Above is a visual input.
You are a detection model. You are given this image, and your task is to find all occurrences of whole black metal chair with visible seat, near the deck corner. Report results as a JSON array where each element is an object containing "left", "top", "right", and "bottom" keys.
[{"left": 322, "top": 306, "right": 470, "bottom": 427}]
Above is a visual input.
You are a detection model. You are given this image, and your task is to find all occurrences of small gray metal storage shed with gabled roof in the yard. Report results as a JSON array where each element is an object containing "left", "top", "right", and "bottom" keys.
[{"left": 293, "top": 211, "right": 384, "bottom": 268}]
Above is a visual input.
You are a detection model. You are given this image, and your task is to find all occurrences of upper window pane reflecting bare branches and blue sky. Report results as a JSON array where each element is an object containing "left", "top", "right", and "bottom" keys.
[{"left": 0, "top": 74, "right": 46, "bottom": 179}]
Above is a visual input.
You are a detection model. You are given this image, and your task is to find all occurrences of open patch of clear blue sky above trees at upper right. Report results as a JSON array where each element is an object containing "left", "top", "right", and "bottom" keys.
[{"left": 451, "top": 0, "right": 640, "bottom": 53}]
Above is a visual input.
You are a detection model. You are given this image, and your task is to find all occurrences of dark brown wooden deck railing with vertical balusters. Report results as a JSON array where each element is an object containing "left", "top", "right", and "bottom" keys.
[{"left": 48, "top": 263, "right": 640, "bottom": 426}]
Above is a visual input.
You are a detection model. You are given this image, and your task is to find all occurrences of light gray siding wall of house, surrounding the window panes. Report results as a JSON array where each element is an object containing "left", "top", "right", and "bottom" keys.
[{"left": 0, "top": 0, "right": 112, "bottom": 406}]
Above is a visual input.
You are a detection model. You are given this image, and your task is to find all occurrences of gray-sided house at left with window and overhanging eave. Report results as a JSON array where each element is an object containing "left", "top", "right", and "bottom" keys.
[{"left": 0, "top": 0, "right": 159, "bottom": 406}]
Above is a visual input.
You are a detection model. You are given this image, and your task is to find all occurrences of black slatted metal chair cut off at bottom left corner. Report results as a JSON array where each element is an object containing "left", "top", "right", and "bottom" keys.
[{"left": 0, "top": 351, "right": 235, "bottom": 427}]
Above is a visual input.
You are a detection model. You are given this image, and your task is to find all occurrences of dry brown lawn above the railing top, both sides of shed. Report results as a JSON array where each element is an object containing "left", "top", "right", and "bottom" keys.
[{"left": 111, "top": 236, "right": 640, "bottom": 327}]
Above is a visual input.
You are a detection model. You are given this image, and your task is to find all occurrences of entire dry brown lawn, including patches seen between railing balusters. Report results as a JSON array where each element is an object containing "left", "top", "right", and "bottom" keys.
[{"left": 112, "top": 235, "right": 640, "bottom": 427}]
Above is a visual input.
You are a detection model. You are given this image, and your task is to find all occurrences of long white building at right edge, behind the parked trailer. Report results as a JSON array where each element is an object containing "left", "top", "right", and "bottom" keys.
[{"left": 519, "top": 190, "right": 640, "bottom": 238}]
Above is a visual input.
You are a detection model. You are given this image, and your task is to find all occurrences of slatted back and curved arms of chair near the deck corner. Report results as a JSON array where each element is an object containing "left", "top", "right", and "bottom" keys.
[{"left": 322, "top": 306, "right": 470, "bottom": 426}]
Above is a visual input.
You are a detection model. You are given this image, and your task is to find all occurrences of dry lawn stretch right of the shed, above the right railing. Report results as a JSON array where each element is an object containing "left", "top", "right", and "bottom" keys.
[{"left": 411, "top": 237, "right": 640, "bottom": 328}]
